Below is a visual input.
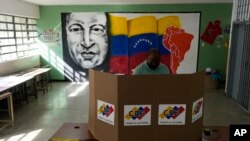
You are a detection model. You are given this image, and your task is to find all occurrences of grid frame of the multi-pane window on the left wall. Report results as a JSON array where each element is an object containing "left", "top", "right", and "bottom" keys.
[{"left": 0, "top": 13, "right": 38, "bottom": 63}]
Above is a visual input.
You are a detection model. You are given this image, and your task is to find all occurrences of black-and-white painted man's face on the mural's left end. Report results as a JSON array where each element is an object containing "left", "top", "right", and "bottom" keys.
[{"left": 62, "top": 12, "right": 110, "bottom": 81}]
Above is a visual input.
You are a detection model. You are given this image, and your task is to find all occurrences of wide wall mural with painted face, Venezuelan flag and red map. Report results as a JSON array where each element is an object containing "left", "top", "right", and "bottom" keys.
[{"left": 62, "top": 12, "right": 200, "bottom": 81}]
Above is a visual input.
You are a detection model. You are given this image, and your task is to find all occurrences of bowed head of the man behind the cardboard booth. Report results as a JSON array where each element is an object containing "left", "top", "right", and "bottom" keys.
[{"left": 147, "top": 48, "right": 161, "bottom": 69}]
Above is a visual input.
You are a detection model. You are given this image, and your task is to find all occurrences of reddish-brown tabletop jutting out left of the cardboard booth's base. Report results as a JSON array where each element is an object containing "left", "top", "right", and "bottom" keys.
[{"left": 49, "top": 123, "right": 97, "bottom": 141}]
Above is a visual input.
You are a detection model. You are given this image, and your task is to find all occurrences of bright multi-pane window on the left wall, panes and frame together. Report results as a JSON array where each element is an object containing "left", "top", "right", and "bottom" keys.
[{"left": 0, "top": 14, "right": 38, "bottom": 62}]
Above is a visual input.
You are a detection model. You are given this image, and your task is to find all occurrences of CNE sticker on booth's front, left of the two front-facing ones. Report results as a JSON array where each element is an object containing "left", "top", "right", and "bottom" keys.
[{"left": 124, "top": 105, "right": 152, "bottom": 126}]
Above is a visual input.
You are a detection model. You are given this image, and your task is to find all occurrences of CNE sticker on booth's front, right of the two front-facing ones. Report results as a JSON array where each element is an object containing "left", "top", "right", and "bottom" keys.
[{"left": 158, "top": 104, "right": 186, "bottom": 125}]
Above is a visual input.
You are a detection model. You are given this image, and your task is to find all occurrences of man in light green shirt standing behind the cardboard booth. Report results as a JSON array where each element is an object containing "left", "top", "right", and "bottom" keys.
[{"left": 133, "top": 48, "right": 170, "bottom": 75}]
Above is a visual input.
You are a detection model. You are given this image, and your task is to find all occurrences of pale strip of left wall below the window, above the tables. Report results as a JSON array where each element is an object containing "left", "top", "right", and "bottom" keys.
[{"left": 0, "top": 55, "right": 40, "bottom": 76}]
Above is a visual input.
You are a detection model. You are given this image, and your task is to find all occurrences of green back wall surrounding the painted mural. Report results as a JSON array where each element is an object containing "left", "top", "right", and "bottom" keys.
[{"left": 38, "top": 3, "right": 232, "bottom": 80}]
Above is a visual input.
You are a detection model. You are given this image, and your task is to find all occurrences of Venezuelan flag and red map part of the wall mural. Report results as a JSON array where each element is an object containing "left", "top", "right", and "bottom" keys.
[{"left": 109, "top": 13, "right": 200, "bottom": 74}]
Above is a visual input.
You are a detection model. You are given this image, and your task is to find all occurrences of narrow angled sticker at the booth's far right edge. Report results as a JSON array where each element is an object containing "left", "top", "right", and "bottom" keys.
[{"left": 192, "top": 98, "right": 203, "bottom": 123}]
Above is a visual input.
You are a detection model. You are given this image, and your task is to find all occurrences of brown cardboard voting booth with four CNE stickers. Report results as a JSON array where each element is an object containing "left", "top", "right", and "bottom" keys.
[{"left": 88, "top": 70, "right": 204, "bottom": 141}]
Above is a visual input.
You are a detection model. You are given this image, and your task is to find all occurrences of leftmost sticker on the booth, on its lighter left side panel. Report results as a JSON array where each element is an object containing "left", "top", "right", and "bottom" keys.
[{"left": 97, "top": 100, "right": 115, "bottom": 125}]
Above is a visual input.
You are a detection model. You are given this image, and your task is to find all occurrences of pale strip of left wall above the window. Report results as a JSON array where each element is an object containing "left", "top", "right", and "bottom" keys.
[{"left": 0, "top": 0, "right": 40, "bottom": 18}]
